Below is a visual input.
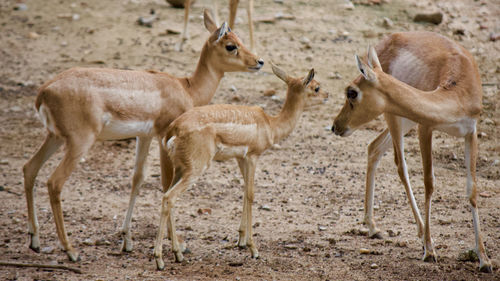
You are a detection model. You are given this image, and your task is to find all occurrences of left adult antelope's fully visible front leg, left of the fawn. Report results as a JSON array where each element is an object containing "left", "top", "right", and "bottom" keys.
[{"left": 122, "top": 137, "right": 152, "bottom": 252}]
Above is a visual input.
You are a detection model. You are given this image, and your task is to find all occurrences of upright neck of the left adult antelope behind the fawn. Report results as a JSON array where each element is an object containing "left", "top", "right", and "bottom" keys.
[{"left": 185, "top": 44, "right": 224, "bottom": 106}]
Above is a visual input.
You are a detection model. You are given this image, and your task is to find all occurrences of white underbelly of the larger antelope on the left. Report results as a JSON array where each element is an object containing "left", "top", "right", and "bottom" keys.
[{"left": 97, "top": 114, "right": 154, "bottom": 140}]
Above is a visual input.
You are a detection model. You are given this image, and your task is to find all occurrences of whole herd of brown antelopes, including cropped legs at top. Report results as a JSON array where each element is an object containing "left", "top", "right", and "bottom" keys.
[{"left": 23, "top": 1, "right": 492, "bottom": 272}]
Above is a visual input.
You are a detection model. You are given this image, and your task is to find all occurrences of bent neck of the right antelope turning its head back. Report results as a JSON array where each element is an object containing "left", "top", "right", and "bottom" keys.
[{"left": 378, "top": 73, "right": 465, "bottom": 125}]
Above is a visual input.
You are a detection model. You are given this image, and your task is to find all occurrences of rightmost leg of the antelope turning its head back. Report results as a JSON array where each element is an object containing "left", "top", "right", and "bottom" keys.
[{"left": 465, "top": 132, "right": 493, "bottom": 272}]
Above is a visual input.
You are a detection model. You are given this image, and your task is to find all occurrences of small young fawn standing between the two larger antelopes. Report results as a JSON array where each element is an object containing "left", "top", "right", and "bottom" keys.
[{"left": 154, "top": 62, "right": 327, "bottom": 270}]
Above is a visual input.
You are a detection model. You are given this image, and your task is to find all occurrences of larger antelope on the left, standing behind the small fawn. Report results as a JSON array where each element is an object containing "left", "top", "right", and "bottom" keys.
[{"left": 23, "top": 11, "right": 264, "bottom": 261}]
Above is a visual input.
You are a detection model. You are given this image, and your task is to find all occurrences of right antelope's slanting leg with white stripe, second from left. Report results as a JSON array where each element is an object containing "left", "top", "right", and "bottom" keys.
[{"left": 386, "top": 117, "right": 423, "bottom": 238}]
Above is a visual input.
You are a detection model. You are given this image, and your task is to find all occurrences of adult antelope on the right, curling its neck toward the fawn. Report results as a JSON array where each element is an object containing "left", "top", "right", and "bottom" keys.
[{"left": 332, "top": 32, "right": 492, "bottom": 272}]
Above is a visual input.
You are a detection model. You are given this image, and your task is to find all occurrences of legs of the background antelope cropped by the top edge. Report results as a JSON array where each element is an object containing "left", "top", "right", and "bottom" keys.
[{"left": 176, "top": 0, "right": 255, "bottom": 52}]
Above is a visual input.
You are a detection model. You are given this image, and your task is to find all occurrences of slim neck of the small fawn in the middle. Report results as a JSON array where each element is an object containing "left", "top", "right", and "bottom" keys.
[{"left": 269, "top": 89, "right": 304, "bottom": 143}]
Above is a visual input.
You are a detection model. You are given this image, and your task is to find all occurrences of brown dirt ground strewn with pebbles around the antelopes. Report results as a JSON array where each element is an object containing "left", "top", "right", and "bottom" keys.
[{"left": 0, "top": 0, "right": 500, "bottom": 280}]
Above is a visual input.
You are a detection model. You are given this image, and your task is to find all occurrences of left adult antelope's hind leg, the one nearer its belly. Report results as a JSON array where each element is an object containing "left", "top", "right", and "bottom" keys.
[{"left": 47, "top": 133, "right": 95, "bottom": 261}]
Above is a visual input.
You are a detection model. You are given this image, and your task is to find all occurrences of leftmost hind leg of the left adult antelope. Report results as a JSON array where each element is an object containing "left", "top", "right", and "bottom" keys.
[{"left": 23, "top": 132, "right": 63, "bottom": 250}]
